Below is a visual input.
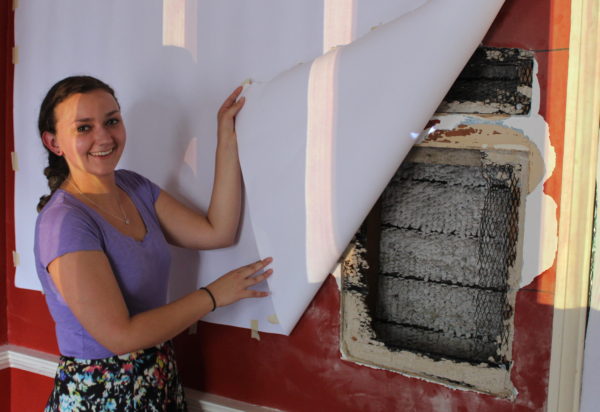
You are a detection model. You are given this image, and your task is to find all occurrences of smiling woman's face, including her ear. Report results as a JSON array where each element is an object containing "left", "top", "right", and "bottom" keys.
[{"left": 43, "top": 90, "right": 126, "bottom": 182}]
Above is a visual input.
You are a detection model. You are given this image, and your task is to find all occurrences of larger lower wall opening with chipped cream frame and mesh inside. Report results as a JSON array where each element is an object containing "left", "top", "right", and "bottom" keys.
[{"left": 342, "top": 143, "right": 528, "bottom": 397}]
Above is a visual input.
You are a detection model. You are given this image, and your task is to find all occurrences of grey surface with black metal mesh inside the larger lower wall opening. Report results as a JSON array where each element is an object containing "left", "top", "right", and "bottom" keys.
[{"left": 373, "top": 158, "right": 520, "bottom": 364}]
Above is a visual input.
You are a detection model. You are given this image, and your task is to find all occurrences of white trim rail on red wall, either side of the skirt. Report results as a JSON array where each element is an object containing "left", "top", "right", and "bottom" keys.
[{"left": 0, "top": 345, "right": 277, "bottom": 412}]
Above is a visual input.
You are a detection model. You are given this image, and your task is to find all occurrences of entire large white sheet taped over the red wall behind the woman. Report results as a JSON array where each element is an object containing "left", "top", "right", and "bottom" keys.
[{"left": 14, "top": 0, "right": 503, "bottom": 334}]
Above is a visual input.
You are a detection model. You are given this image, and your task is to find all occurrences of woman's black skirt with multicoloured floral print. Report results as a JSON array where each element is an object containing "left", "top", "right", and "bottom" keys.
[{"left": 44, "top": 342, "right": 187, "bottom": 412}]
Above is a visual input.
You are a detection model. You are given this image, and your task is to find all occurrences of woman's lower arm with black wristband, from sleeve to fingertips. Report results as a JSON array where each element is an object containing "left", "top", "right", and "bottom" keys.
[{"left": 48, "top": 251, "right": 272, "bottom": 354}]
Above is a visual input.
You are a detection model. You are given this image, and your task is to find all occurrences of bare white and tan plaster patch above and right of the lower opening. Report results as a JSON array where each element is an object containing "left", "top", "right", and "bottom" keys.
[{"left": 425, "top": 109, "right": 558, "bottom": 290}]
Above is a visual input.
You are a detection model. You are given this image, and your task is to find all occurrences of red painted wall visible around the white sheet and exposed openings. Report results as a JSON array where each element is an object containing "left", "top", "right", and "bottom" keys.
[{"left": 0, "top": 0, "right": 570, "bottom": 412}]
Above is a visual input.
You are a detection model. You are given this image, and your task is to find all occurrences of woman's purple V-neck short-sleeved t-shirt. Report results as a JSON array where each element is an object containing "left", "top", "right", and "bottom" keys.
[{"left": 34, "top": 170, "right": 171, "bottom": 359}]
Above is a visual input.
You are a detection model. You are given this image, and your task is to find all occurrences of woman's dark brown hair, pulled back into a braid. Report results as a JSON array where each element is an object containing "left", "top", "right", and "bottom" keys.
[{"left": 37, "top": 76, "right": 119, "bottom": 212}]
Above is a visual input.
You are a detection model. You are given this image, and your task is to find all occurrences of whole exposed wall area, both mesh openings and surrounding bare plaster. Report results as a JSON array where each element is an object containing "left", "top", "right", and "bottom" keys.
[{"left": 341, "top": 48, "right": 557, "bottom": 398}]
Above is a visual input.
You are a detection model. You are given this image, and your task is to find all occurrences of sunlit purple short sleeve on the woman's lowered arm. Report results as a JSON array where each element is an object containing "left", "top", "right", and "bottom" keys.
[{"left": 36, "top": 203, "right": 104, "bottom": 268}]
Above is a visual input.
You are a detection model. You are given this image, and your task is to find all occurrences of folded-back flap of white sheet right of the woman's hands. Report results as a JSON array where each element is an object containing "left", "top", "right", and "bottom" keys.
[{"left": 237, "top": 0, "right": 503, "bottom": 333}]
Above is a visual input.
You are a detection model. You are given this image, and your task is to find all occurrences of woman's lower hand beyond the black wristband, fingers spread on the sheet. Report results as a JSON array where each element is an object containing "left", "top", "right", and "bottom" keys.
[{"left": 206, "top": 257, "right": 273, "bottom": 307}]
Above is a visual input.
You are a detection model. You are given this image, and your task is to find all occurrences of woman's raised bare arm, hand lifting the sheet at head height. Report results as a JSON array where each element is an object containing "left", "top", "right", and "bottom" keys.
[{"left": 155, "top": 86, "right": 244, "bottom": 249}]
